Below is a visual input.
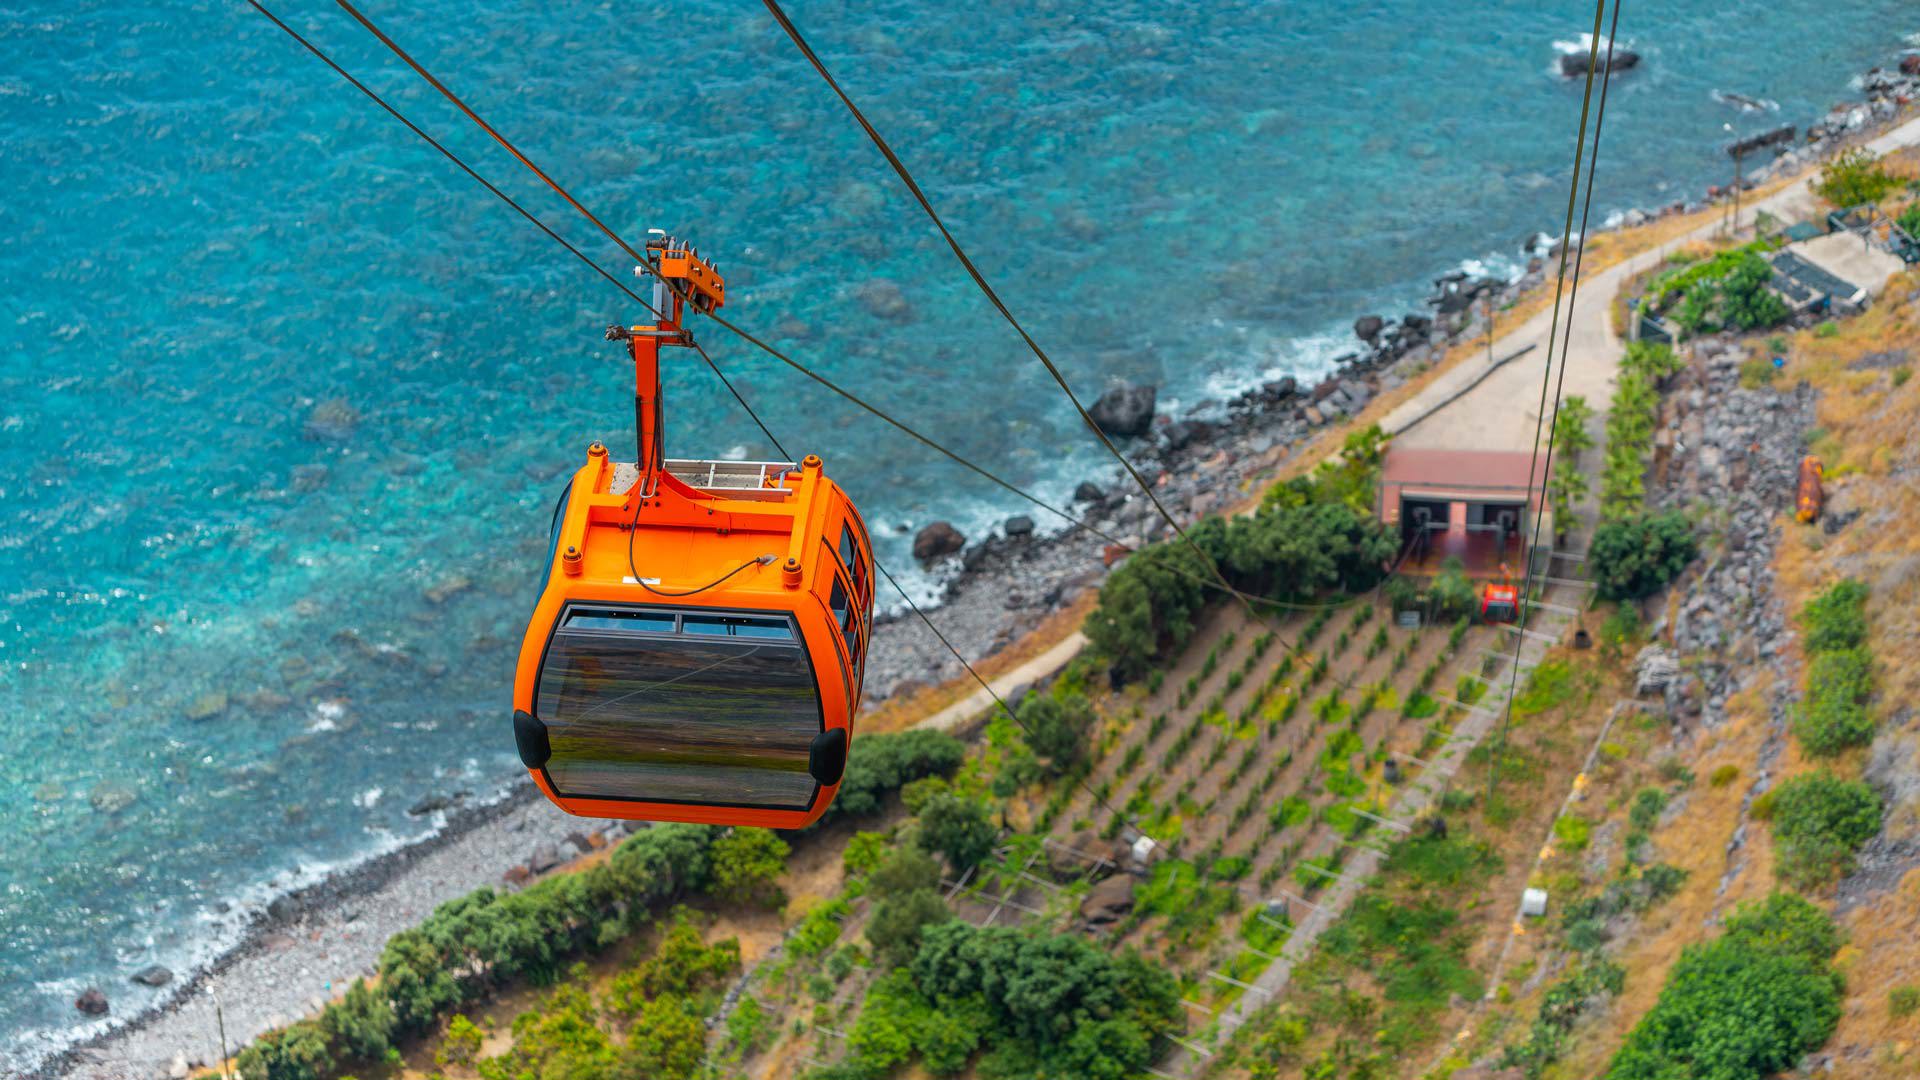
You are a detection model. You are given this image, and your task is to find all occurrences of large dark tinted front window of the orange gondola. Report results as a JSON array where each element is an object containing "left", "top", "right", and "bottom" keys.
[{"left": 536, "top": 607, "right": 822, "bottom": 809}]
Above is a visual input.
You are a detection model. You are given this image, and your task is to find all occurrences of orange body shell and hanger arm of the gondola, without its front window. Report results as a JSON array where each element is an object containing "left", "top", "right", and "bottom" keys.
[{"left": 513, "top": 244, "right": 874, "bottom": 828}]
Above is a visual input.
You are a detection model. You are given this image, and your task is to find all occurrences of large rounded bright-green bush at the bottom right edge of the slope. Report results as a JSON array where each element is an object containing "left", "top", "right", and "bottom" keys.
[{"left": 1607, "top": 894, "right": 1841, "bottom": 1080}]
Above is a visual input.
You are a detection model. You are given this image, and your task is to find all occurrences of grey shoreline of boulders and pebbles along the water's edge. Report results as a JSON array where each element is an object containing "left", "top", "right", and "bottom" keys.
[{"left": 41, "top": 37, "right": 1920, "bottom": 1080}]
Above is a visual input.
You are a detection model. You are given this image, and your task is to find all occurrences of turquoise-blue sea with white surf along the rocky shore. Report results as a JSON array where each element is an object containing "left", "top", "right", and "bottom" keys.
[{"left": 0, "top": 0, "right": 1920, "bottom": 1070}]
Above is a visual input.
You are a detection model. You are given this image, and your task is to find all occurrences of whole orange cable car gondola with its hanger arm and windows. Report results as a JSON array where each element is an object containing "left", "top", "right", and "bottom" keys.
[{"left": 513, "top": 231, "right": 874, "bottom": 828}]
